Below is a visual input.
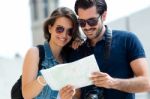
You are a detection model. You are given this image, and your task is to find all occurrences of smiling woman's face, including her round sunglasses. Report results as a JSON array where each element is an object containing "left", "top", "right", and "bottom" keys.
[{"left": 49, "top": 17, "right": 73, "bottom": 47}]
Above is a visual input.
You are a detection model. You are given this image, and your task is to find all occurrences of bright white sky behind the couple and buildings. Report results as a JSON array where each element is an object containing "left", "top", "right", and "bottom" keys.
[{"left": 0, "top": 0, "right": 150, "bottom": 57}]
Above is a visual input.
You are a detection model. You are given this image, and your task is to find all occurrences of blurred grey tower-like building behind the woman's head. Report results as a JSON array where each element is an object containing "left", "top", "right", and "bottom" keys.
[{"left": 30, "top": 0, "right": 59, "bottom": 45}]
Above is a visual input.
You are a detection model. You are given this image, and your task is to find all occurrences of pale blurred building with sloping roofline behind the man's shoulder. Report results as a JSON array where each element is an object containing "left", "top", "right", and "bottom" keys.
[{"left": 108, "top": 7, "right": 150, "bottom": 64}]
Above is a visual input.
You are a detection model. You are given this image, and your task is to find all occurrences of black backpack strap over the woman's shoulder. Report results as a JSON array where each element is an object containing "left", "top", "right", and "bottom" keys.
[{"left": 37, "top": 45, "right": 45, "bottom": 70}]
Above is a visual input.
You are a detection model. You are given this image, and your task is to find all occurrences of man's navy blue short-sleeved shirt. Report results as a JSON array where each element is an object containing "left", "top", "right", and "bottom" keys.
[{"left": 68, "top": 30, "right": 145, "bottom": 99}]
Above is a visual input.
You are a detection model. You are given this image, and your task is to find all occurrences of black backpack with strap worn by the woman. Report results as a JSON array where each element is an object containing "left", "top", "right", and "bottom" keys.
[{"left": 11, "top": 45, "right": 45, "bottom": 99}]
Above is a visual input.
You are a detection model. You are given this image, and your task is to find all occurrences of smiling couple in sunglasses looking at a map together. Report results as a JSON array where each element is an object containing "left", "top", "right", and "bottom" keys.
[{"left": 22, "top": 0, "right": 149, "bottom": 99}]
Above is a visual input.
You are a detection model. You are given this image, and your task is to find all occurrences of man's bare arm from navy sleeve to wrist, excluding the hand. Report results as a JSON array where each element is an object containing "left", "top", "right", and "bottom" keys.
[{"left": 113, "top": 58, "right": 150, "bottom": 92}]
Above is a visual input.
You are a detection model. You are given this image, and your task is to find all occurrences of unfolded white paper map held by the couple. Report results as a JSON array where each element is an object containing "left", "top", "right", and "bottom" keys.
[{"left": 41, "top": 55, "right": 100, "bottom": 90}]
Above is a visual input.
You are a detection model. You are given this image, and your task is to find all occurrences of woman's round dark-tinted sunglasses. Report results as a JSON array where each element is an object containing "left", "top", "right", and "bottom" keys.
[{"left": 55, "top": 26, "right": 73, "bottom": 36}]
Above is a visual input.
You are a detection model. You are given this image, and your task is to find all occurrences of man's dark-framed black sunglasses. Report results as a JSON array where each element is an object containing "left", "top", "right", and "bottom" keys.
[{"left": 78, "top": 16, "right": 100, "bottom": 27}]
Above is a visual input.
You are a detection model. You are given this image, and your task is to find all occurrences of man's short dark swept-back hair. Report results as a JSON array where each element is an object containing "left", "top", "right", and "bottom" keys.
[{"left": 74, "top": 0, "right": 107, "bottom": 15}]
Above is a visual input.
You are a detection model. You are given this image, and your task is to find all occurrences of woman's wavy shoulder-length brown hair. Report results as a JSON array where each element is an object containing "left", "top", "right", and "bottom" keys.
[{"left": 43, "top": 7, "right": 80, "bottom": 42}]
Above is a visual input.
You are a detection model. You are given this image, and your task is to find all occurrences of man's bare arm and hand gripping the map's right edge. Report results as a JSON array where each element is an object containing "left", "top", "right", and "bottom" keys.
[{"left": 91, "top": 58, "right": 150, "bottom": 93}]
